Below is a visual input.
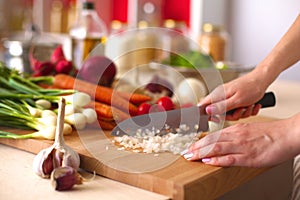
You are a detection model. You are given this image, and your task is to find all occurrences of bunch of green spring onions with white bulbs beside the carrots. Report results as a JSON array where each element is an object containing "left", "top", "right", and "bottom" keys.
[{"left": 0, "top": 63, "right": 97, "bottom": 139}]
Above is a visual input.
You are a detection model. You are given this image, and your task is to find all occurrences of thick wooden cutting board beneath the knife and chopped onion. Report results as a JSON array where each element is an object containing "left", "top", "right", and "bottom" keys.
[{"left": 0, "top": 116, "right": 273, "bottom": 200}]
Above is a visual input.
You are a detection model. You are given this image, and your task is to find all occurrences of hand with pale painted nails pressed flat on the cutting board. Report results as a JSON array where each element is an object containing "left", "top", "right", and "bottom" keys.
[{"left": 184, "top": 114, "right": 300, "bottom": 167}]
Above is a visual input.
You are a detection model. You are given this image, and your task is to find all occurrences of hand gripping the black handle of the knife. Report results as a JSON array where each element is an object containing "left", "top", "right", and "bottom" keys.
[{"left": 199, "top": 72, "right": 266, "bottom": 120}]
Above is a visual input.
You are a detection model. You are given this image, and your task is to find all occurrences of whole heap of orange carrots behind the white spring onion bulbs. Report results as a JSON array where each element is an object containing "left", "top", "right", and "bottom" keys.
[{"left": 31, "top": 74, "right": 151, "bottom": 130}]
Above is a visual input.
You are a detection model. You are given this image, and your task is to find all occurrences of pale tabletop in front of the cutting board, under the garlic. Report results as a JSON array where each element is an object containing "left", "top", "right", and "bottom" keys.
[{"left": 0, "top": 144, "right": 168, "bottom": 200}]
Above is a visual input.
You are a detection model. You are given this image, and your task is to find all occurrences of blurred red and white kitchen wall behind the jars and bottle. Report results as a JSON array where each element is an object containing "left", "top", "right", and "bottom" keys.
[{"left": 0, "top": 0, "right": 300, "bottom": 81}]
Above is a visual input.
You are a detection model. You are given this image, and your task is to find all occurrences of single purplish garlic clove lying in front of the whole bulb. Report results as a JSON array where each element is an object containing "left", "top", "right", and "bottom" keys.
[{"left": 51, "top": 166, "right": 83, "bottom": 191}]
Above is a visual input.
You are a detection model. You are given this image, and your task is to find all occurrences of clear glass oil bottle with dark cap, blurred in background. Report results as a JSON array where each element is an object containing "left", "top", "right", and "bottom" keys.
[{"left": 70, "top": 2, "right": 108, "bottom": 69}]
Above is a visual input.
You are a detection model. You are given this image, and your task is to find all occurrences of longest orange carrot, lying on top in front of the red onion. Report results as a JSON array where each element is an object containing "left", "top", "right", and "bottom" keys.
[{"left": 53, "top": 74, "right": 138, "bottom": 115}]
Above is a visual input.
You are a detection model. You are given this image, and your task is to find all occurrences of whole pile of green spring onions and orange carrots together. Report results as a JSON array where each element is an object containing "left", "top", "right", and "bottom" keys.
[{"left": 0, "top": 57, "right": 151, "bottom": 135}]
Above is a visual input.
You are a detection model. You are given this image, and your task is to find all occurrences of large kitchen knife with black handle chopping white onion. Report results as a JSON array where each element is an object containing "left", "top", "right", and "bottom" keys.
[{"left": 111, "top": 92, "right": 276, "bottom": 136}]
